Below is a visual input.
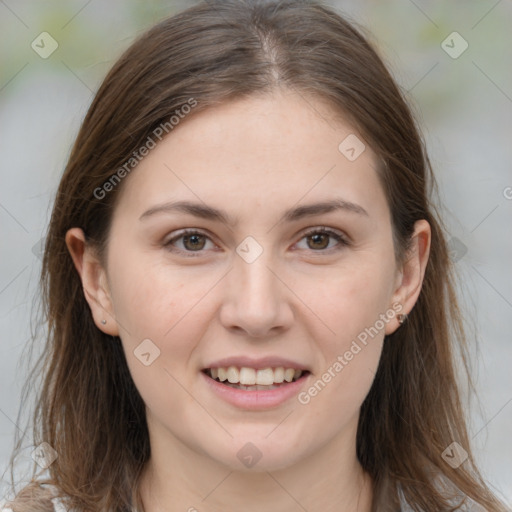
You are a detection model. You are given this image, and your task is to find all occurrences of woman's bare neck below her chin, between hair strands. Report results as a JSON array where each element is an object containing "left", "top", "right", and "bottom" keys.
[{"left": 140, "top": 420, "right": 373, "bottom": 512}]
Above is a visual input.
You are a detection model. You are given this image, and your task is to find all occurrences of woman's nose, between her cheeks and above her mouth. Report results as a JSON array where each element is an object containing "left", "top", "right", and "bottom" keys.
[{"left": 220, "top": 251, "right": 294, "bottom": 338}]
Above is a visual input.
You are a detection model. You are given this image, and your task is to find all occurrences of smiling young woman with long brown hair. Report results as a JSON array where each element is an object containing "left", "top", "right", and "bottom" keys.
[{"left": 3, "top": 0, "right": 505, "bottom": 512}]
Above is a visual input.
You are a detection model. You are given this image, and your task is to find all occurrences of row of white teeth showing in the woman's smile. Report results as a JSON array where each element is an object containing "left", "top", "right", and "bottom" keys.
[{"left": 208, "top": 366, "right": 303, "bottom": 390}]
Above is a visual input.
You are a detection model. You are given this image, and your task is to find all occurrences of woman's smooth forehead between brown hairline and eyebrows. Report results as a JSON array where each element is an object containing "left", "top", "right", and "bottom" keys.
[{"left": 112, "top": 93, "right": 387, "bottom": 222}]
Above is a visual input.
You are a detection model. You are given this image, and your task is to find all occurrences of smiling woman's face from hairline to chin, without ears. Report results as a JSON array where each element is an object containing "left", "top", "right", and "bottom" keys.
[{"left": 78, "top": 93, "right": 412, "bottom": 470}]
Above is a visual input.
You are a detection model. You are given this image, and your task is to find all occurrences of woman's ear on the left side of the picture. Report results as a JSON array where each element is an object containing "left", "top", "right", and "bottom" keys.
[{"left": 66, "top": 228, "right": 119, "bottom": 336}]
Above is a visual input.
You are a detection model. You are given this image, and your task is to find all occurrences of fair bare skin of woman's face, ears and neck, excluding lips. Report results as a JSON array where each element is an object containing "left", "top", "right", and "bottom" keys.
[{"left": 66, "top": 91, "right": 430, "bottom": 512}]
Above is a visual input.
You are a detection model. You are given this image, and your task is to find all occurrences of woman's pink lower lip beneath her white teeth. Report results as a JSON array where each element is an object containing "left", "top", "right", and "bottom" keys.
[{"left": 200, "top": 372, "right": 311, "bottom": 410}]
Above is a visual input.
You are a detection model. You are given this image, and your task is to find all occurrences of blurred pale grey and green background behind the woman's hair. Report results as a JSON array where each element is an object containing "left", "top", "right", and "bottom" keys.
[{"left": 0, "top": 0, "right": 512, "bottom": 504}]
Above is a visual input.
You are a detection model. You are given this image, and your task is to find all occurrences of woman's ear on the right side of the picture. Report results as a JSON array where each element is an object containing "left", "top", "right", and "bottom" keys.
[{"left": 385, "top": 219, "right": 431, "bottom": 334}]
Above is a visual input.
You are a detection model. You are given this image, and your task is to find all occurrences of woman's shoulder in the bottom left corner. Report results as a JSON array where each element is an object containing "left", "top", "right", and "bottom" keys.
[{"left": 0, "top": 482, "right": 72, "bottom": 512}]
